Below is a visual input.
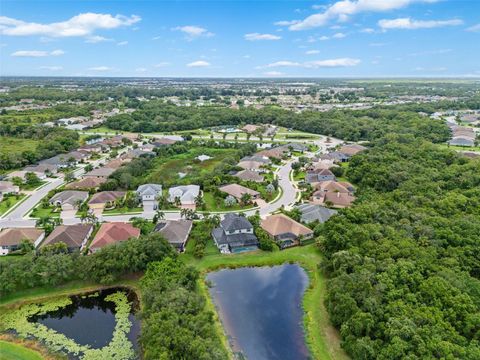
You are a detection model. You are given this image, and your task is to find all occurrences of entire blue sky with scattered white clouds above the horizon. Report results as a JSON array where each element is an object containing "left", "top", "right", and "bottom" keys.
[{"left": 0, "top": 0, "right": 480, "bottom": 77}]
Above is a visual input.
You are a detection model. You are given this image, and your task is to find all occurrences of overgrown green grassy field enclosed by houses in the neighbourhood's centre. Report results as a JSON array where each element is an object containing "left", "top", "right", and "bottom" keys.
[{"left": 145, "top": 148, "right": 236, "bottom": 186}]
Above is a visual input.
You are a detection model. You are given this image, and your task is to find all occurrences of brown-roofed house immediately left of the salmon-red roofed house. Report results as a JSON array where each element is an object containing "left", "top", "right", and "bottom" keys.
[{"left": 40, "top": 224, "right": 93, "bottom": 251}]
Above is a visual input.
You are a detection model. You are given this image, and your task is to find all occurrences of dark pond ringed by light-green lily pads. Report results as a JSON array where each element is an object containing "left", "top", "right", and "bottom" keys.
[{"left": 5, "top": 288, "right": 140, "bottom": 360}]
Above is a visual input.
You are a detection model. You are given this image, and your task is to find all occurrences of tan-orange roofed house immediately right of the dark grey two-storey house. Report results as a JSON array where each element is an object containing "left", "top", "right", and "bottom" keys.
[{"left": 260, "top": 214, "right": 313, "bottom": 249}]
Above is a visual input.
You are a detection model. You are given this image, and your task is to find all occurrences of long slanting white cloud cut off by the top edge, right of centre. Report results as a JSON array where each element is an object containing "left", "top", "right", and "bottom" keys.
[{"left": 289, "top": 0, "right": 437, "bottom": 31}]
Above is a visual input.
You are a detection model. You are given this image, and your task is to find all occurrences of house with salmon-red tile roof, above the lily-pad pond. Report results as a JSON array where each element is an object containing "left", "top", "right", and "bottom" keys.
[{"left": 90, "top": 222, "right": 140, "bottom": 252}]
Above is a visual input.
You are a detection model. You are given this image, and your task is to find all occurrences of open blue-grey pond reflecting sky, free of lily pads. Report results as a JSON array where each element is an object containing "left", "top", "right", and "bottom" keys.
[{"left": 207, "top": 264, "right": 310, "bottom": 360}]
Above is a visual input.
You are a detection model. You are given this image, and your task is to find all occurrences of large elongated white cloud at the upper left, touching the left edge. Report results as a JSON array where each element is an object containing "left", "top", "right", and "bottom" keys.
[{"left": 0, "top": 13, "right": 141, "bottom": 37}]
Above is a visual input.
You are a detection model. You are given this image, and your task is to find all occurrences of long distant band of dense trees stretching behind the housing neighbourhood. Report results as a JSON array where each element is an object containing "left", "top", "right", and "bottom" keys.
[{"left": 106, "top": 101, "right": 449, "bottom": 142}]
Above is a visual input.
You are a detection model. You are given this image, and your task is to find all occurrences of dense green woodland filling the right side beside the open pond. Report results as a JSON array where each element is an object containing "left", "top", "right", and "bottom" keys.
[{"left": 319, "top": 135, "right": 480, "bottom": 359}]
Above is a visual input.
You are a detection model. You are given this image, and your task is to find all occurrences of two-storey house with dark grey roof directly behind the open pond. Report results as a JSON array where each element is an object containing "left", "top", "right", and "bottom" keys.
[{"left": 212, "top": 213, "right": 258, "bottom": 253}]
